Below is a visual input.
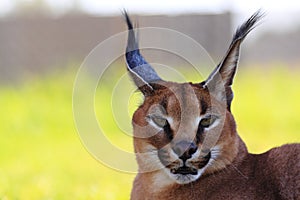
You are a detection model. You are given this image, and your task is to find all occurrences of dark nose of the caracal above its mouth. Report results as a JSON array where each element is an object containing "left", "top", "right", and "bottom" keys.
[{"left": 172, "top": 141, "right": 198, "bottom": 162}]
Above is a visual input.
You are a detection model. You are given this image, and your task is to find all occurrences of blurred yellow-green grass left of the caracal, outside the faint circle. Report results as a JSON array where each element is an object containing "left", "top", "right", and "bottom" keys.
[{"left": 0, "top": 72, "right": 134, "bottom": 200}]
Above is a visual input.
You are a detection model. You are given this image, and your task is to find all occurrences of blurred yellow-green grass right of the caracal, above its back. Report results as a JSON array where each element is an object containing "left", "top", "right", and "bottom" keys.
[{"left": 232, "top": 64, "right": 300, "bottom": 153}]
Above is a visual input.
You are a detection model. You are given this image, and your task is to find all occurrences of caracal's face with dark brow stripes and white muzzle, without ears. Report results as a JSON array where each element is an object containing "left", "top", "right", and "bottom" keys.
[{"left": 133, "top": 82, "right": 237, "bottom": 184}]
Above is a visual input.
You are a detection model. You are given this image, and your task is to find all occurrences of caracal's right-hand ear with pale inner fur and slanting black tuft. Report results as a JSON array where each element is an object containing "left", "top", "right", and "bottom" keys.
[{"left": 202, "top": 10, "right": 264, "bottom": 111}]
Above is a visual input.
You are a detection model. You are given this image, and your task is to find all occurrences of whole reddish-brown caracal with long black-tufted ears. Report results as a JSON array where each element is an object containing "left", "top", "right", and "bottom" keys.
[{"left": 125, "top": 12, "right": 300, "bottom": 200}]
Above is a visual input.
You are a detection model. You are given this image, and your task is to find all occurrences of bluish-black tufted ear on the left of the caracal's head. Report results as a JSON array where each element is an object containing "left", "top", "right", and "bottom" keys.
[{"left": 123, "top": 11, "right": 162, "bottom": 95}]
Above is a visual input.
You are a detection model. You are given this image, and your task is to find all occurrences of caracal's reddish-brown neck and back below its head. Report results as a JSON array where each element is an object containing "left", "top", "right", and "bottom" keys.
[{"left": 137, "top": 141, "right": 300, "bottom": 200}]
